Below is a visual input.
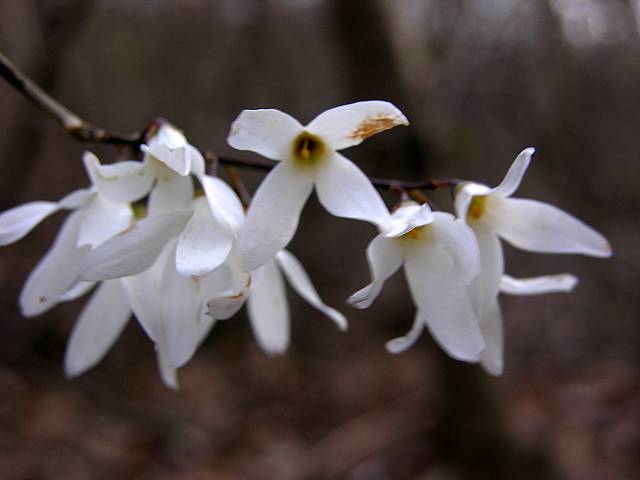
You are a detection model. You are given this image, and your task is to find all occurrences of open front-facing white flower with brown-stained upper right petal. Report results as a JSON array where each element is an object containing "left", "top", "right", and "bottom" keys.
[{"left": 227, "top": 101, "right": 408, "bottom": 271}]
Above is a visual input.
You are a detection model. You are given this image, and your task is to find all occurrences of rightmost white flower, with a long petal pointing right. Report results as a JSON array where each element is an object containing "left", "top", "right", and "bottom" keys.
[{"left": 455, "top": 148, "right": 611, "bottom": 375}]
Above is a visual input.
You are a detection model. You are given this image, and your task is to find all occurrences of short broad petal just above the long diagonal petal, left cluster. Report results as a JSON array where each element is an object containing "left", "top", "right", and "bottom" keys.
[{"left": 77, "top": 195, "right": 133, "bottom": 248}]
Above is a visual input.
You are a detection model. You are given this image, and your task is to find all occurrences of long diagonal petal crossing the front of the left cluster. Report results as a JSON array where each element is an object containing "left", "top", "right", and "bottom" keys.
[{"left": 81, "top": 210, "right": 191, "bottom": 280}]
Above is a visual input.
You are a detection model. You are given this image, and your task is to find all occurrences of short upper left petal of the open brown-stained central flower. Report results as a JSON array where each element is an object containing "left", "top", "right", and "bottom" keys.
[{"left": 227, "top": 109, "right": 302, "bottom": 160}]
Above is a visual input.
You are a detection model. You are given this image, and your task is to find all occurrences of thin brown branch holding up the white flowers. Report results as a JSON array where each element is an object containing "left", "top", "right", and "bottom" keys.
[{"left": 0, "top": 52, "right": 460, "bottom": 191}]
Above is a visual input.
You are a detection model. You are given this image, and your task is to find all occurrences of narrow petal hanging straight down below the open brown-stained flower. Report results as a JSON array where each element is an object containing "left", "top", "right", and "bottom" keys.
[{"left": 247, "top": 261, "right": 289, "bottom": 354}]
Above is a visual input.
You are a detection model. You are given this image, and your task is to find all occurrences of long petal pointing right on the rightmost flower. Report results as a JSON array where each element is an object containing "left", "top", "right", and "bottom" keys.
[{"left": 493, "top": 198, "right": 611, "bottom": 257}]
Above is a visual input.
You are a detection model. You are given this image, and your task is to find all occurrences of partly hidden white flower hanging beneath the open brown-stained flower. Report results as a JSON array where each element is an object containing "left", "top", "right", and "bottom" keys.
[{"left": 208, "top": 250, "right": 347, "bottom": 354}]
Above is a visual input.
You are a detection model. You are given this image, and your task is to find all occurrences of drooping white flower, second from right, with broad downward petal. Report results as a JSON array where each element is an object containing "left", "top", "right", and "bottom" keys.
[{"left": 348, "top": 202, "right": 484, "bottom": 362}]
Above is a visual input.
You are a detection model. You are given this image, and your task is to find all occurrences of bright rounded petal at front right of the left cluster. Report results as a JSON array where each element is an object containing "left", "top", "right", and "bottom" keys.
[{"left": 176, "top": 197, "right": 234, "bottom": 277}]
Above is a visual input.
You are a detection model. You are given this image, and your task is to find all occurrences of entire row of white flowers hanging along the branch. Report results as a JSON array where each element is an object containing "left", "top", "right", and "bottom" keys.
[{"left": 0, "top": 101, "right": 611, "bottom": 388}]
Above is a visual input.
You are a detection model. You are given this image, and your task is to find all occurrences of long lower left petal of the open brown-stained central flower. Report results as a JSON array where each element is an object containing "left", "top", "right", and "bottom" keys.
[{"left": 238, "top": 162, "right": 313, "bottom": 271}]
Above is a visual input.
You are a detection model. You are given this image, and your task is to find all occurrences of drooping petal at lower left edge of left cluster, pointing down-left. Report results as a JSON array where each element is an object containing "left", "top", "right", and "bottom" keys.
[{"left": 19, "top": 211, "right": 89, "bottom": 317}]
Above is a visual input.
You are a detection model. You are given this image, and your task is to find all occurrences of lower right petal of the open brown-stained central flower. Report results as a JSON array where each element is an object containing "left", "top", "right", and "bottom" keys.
[{"left": 316, "top": 153, "right": 392, "bottom": 231}]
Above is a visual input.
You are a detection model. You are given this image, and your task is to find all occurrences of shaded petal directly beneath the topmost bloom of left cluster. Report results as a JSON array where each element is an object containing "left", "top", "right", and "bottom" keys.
[{"left": 149, "top": 168, "right": 193, "bottom": 215}]
